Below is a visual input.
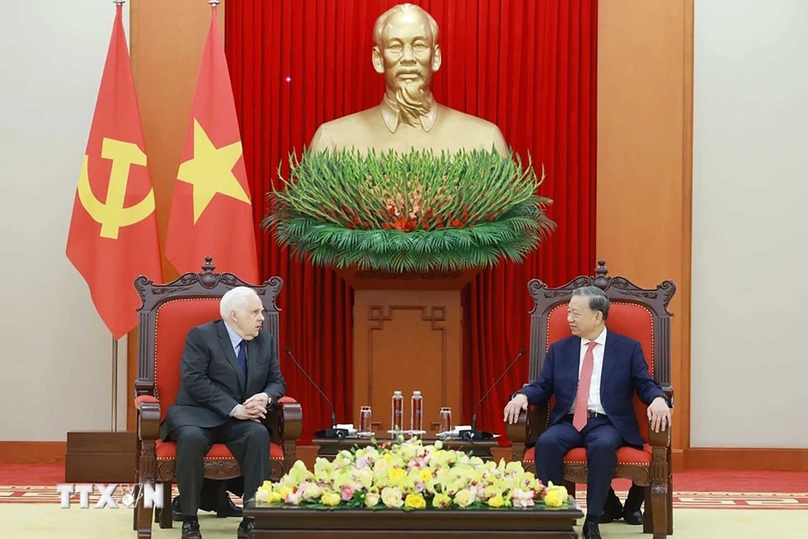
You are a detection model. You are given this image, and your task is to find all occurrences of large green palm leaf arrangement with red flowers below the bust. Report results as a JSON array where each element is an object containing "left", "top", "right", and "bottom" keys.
[{"left": 262, "top": 150, "right": 555, "bottom": 272}]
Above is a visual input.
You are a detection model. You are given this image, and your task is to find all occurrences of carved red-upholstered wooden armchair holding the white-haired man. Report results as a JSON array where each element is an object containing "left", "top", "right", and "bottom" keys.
[{"left": 134, "top": 257, "right": 303, "bottom": 538}]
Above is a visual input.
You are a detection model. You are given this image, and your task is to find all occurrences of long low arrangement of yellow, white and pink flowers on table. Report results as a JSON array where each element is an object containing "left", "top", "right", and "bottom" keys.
[{"left": 256, "top": 438, "right": 569, "bottom": 510}]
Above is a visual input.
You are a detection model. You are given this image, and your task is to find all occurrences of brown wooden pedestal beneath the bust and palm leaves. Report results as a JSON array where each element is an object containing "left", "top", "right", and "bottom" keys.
[{"left": 336, "top": 268, "right": 480, "bottom": 432}]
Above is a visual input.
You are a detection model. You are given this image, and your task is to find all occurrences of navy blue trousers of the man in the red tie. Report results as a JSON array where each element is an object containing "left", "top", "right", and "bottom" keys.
[{"left": 535, "top": 415, "right": 629, "bottom": 517}]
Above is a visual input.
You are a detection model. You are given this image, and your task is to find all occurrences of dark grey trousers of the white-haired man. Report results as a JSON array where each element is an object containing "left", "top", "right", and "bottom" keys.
[{"left": 169, "top": 419, "right": 270, "bottom": 517}]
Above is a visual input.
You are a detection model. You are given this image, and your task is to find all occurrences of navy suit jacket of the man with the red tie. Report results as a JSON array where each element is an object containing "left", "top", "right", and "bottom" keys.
[{"left": 517, "top": 331, "right": 670, "bottom": 446}]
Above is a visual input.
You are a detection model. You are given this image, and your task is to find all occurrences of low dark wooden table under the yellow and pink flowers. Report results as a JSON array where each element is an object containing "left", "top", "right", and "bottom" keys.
[{"left": 244, "top": 499, "right": 584, "bottom": 539}]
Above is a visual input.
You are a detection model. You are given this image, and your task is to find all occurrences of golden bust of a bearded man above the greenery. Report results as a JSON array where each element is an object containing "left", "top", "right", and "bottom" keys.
[{"left": 311, "top": 4, "right": 508, "bottom": 155}]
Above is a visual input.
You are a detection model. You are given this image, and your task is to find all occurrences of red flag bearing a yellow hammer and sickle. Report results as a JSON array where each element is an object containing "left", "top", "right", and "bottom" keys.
[{"left": 67, "top": 4, "right": 163, "bottom": 340}]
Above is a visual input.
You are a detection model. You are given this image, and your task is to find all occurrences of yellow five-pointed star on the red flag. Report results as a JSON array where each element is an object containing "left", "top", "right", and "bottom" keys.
[{"left": 177, "top": 118, "right": 250, "bottom": 224}]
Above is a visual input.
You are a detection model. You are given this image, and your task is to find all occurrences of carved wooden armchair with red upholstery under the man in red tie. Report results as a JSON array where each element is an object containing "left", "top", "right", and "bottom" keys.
[{"left": 507, "top": 260, "right": 676, "bottom": 539}]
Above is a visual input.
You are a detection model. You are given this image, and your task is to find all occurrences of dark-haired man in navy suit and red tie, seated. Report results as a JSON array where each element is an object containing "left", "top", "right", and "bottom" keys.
[{"left": 505, "top": 286, "right": 670, "bottom": 539}]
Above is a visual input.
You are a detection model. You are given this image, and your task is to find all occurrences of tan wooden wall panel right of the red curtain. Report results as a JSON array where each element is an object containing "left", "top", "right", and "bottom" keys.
[{"left": 597, "top": 0, "right": 693, "bottom": 465}]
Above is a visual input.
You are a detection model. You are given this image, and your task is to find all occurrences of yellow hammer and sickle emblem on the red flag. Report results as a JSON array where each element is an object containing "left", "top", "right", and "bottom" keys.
[{"left": 78, "top": 138, "right": 154, "bottom": 239}]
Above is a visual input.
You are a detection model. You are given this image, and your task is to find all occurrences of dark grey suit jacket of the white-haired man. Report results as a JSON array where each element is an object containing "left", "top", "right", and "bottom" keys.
[{"left": 160, "top": 320, "right": 286, "bottom": 439}]
